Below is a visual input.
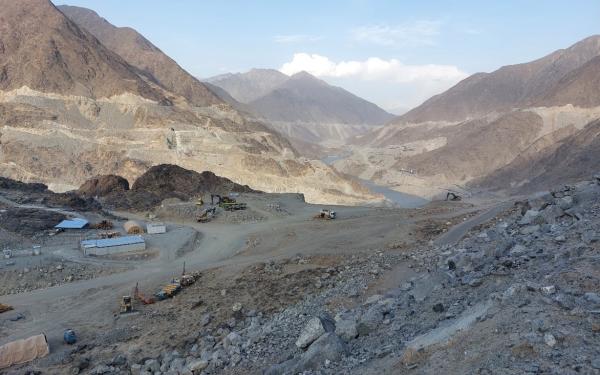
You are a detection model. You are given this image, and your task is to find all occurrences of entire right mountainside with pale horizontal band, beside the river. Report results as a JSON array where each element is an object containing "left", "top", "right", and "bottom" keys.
[{"left": 336, "top": 36, "right": 600, "bottom": 196}]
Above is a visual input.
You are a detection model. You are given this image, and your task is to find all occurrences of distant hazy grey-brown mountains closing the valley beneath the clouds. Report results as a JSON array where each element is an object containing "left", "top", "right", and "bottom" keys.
[{"left": 206, "top": 69, "right": 394, "bottom": 144}]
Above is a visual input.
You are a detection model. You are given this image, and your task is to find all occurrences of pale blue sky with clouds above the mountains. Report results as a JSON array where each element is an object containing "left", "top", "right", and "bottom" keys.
[{"left": 55, "top": 0, "right": 600, "bottom": 113}]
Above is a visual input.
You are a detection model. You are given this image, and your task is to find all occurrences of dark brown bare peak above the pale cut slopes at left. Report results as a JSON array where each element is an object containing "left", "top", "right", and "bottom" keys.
[{"left": 0, "top": 0, "right": 164, "bottom": 101}]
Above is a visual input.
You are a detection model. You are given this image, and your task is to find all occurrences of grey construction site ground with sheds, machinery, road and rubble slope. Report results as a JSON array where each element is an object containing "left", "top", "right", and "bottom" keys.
[{"left": 0, "top": 168, "right": 600, "bottom": 375}]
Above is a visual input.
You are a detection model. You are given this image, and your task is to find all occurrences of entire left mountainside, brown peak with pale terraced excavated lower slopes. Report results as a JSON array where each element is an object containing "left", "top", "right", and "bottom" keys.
[{"left": 0, "top": 0, "right": 380, "bottom": 203}]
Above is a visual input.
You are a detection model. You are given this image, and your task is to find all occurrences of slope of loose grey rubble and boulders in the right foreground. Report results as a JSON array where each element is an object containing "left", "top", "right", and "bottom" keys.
[{"left": 31, "top": 175, "right": 600, "bottom": 375}]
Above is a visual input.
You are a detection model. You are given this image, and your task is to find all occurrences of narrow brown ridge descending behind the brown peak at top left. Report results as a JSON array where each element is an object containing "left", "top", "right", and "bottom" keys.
[{"left": 58, "top": 5, "right": 222, "bottom": 106}]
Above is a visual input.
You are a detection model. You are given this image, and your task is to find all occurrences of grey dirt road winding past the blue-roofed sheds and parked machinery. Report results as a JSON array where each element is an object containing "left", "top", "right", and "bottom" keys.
[{"left": 0, "top": 198, "right": 500, "bottom": 344}]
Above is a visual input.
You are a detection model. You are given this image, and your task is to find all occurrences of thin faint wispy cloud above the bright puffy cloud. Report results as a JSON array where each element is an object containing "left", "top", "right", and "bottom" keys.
[{"left": 352, "top": 20, "right": 441, "bottom": 47}]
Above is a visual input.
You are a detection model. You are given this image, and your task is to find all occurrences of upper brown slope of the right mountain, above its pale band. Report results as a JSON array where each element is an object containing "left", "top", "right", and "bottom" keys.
[{"left": 394, "top": 35, "right": 600, "bottom": 123}]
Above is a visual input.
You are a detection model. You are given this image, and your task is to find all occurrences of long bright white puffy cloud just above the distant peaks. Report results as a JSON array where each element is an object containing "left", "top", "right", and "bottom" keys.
[{"left": 279, "top": 53, "right": 467, "bottom": 83}]
